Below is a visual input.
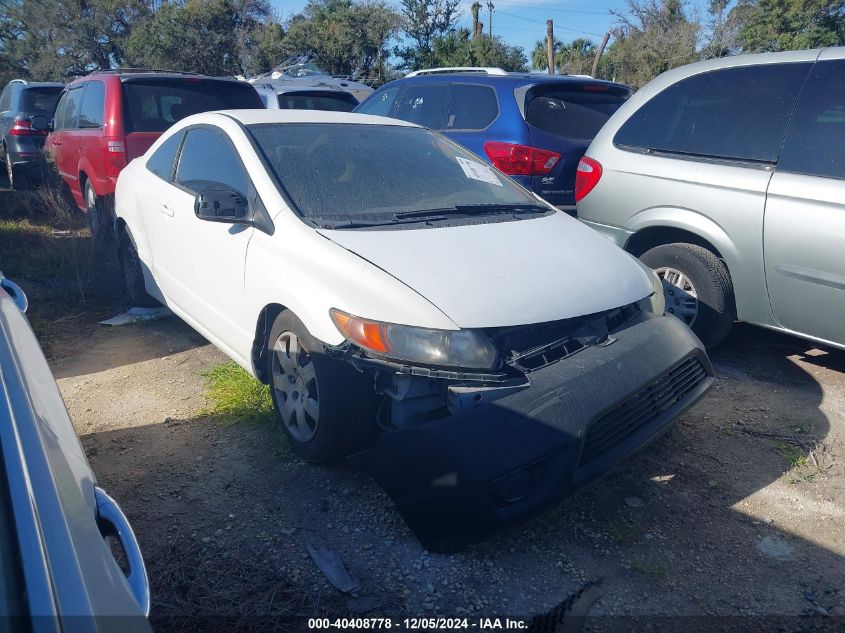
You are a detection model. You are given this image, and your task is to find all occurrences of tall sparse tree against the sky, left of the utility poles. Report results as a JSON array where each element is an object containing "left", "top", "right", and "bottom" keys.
[{"left": 395, "top": 0, "right": 461, "bottom": 70}]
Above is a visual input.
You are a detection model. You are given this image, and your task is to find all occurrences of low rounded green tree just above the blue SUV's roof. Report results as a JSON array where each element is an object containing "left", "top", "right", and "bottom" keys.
[{"left": 430, "top": 29, "right": 528, "bottom": 72}]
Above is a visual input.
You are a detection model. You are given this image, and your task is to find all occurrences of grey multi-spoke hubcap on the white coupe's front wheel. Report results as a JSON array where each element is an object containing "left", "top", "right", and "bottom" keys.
[{"left": 272, "top": 331, "right": 320, "bottom": 443}]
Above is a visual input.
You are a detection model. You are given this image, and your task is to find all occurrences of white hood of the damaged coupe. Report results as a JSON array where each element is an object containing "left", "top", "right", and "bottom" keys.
[{"left": 319, "top": 212, "right": 653, "bottom": 328}]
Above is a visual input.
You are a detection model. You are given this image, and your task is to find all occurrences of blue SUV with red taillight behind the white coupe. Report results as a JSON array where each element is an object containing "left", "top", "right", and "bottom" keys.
[{"left": 355, "top": 68, "right": 631, "bottom": 215}]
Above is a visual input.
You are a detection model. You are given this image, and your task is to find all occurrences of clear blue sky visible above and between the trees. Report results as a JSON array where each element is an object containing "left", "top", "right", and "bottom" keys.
[{"left": 271, "top": 0, "right": 648, "bottom": 61}]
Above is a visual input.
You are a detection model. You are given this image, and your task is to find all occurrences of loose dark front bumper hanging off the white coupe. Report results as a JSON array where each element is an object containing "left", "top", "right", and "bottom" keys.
[{"left": 351, "top": 317, "right": 714, "bottom": 551}]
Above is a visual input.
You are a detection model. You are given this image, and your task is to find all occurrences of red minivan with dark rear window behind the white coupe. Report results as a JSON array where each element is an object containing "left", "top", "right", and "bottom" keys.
[{"left": 46, "top": 69, "right": 264, "bottom": 234}]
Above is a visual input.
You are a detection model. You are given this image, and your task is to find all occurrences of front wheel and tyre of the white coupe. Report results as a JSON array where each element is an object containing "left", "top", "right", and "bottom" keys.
[{"left": 265, "top": 311, "right": 377, "bottom": 464}]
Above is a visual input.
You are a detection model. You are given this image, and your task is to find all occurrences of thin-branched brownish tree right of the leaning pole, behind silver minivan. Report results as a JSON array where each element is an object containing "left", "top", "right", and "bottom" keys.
[{"left": 600, "top": 0, "right": 701, "bottom": 88}]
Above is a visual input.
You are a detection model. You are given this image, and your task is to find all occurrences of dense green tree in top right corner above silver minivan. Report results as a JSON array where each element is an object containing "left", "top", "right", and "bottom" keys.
[{"left": 730, "top": 0, "right": 845, "bottom": 53}]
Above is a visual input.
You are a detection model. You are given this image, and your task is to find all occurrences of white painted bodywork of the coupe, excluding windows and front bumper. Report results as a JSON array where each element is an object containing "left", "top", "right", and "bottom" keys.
[{"left": 115, "top": 110, "right": 653, "bottom": 374}]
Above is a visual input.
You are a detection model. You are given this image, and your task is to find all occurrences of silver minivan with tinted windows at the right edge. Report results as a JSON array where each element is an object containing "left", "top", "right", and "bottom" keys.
[{"left": 576, "top": 48, "right": 845, "bottom": 348}]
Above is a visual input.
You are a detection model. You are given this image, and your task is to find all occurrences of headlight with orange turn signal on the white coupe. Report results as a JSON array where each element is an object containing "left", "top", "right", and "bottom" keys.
[{"left": 329, "top": 308, "right": 498, "bottom": 369}]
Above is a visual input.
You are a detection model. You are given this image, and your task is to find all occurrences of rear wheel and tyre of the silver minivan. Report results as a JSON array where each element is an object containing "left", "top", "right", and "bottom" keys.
[{"left": 640, "top": 243, "right": 736, "bottom": 347}]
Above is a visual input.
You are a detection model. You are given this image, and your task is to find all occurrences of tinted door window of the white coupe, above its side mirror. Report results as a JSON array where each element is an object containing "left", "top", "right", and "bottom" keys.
[{"left": 176, "top": 127, "right": 252, "bottom": 197}]
